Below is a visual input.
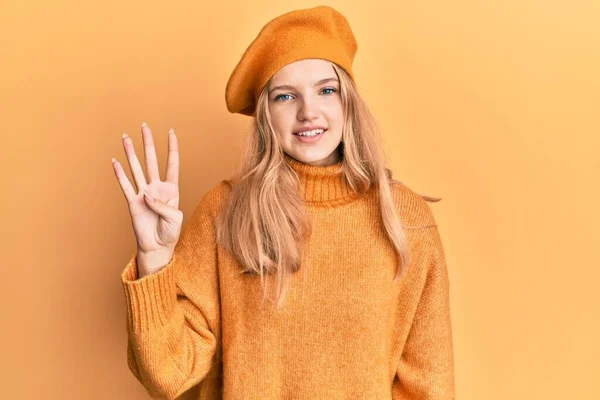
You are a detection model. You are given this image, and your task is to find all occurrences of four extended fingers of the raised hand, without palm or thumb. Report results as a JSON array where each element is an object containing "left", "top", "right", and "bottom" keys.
[{"left": 112, "top": 122, "right": 179, "bottom": 201}]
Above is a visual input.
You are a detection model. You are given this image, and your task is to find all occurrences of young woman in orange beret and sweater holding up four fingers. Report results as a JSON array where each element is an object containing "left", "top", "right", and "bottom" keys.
[{"left": 113, "top": 6, "right": 454, "bottom": 400}]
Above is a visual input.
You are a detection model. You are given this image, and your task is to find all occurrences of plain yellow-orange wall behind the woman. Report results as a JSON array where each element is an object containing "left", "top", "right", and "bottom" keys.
[{"left": 0, "top": 0, "right": 600, "bottom": 400}]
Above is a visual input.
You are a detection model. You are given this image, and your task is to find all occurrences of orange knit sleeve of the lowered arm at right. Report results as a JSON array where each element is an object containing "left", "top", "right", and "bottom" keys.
[{"left": 392, "top": 223, "right": 455, "bottom": 400}]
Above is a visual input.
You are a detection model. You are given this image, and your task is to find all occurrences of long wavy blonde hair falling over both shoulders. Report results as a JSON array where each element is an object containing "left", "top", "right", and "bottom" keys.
[{"left": 217, "top": 63, "right": 440, "bottom": 308}]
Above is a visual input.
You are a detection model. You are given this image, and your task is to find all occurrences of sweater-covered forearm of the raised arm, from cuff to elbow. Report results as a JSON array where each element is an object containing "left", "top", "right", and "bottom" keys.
[{"left": 123, "top": 255, "right": 217, "bottom": 399}]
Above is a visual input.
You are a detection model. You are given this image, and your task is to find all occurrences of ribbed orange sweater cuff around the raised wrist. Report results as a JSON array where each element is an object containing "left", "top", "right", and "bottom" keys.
[{"left": 121, "top": 255, "right": 177, "bottom": 332}]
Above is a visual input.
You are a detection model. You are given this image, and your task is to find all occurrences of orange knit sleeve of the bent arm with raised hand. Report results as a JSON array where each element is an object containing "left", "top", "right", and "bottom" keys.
[{"left": 121, "top": 191, "right": 220, "bottom": 399}]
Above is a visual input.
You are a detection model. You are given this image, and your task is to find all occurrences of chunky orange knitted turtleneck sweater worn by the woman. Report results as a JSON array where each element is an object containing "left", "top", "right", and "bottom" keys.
[{"left": 121, "top": 157, "right": 455, "bottom": 400}]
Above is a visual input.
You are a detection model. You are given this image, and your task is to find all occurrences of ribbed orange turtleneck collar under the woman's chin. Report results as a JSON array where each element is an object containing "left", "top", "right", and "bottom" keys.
[{"left": 284, "top": 154, "right": 360, "bottom": 208}]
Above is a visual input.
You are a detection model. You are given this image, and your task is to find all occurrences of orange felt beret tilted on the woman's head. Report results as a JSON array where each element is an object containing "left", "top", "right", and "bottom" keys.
[{"left": 225, "top": 6, "right": 358, "bottom": 116}]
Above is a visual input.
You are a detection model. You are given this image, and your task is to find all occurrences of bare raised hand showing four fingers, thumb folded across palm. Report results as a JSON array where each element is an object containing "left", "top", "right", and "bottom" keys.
[{"left": 112, "top": 123, "right": 183, "bottom": 275}]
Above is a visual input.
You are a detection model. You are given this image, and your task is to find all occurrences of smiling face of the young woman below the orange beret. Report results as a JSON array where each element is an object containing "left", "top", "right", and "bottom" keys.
[{"left": 269, "top": 59, "right": 344, "bottom": 165}]
